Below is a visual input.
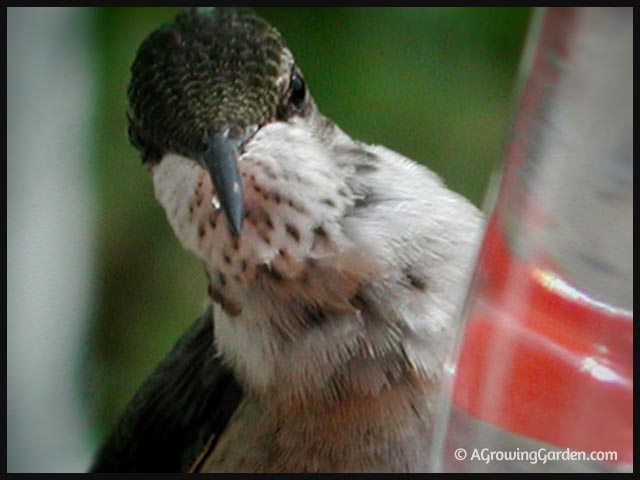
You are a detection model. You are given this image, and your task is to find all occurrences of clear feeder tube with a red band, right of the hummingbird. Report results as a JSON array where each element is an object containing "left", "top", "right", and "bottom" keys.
[{"left": 433, "top": 7, "right": 633, "bottom": 472}]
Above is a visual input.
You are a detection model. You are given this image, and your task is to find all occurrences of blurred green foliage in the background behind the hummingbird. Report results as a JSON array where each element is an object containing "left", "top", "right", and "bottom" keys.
[{"left": 83, "top": 7, "right": 531, "bottom": 441}]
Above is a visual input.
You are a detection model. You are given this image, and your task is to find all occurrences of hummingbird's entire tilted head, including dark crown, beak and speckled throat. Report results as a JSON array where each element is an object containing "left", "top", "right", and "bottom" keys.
[{"left": 128, "top": 8, "right": 358, "bottom": 304}]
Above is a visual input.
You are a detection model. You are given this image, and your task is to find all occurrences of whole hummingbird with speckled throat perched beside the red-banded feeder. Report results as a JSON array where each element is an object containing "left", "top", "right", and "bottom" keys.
[{"left": 91, "top": 8, "right": 483, "bottom": 472}]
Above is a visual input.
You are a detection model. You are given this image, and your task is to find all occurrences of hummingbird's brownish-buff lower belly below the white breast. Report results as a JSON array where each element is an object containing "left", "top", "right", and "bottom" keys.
[{"left": 197, "top": 388, "right": 431, "bottom": 473}]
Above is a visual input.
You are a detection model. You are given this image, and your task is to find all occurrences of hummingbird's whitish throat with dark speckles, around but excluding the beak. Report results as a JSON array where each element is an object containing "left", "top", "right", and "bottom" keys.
[{"left": 152, "top": 118, "right": 371, "bottom": 330}]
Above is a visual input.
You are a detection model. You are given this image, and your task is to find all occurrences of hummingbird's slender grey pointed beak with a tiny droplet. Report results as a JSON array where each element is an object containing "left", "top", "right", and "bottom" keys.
[{"left": 201, "top": 126, "right": 258, "bottom": 236}]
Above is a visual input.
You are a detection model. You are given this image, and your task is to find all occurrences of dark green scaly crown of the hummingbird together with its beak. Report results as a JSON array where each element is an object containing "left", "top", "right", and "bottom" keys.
[{"left": 128, "top": 8, "right": 313, "bottom": 236}]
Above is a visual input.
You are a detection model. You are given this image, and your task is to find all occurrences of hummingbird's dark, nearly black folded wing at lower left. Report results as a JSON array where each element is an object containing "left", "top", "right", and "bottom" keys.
[{"left": 91, "top": 308, "right": 242, "bottom": 472}]
